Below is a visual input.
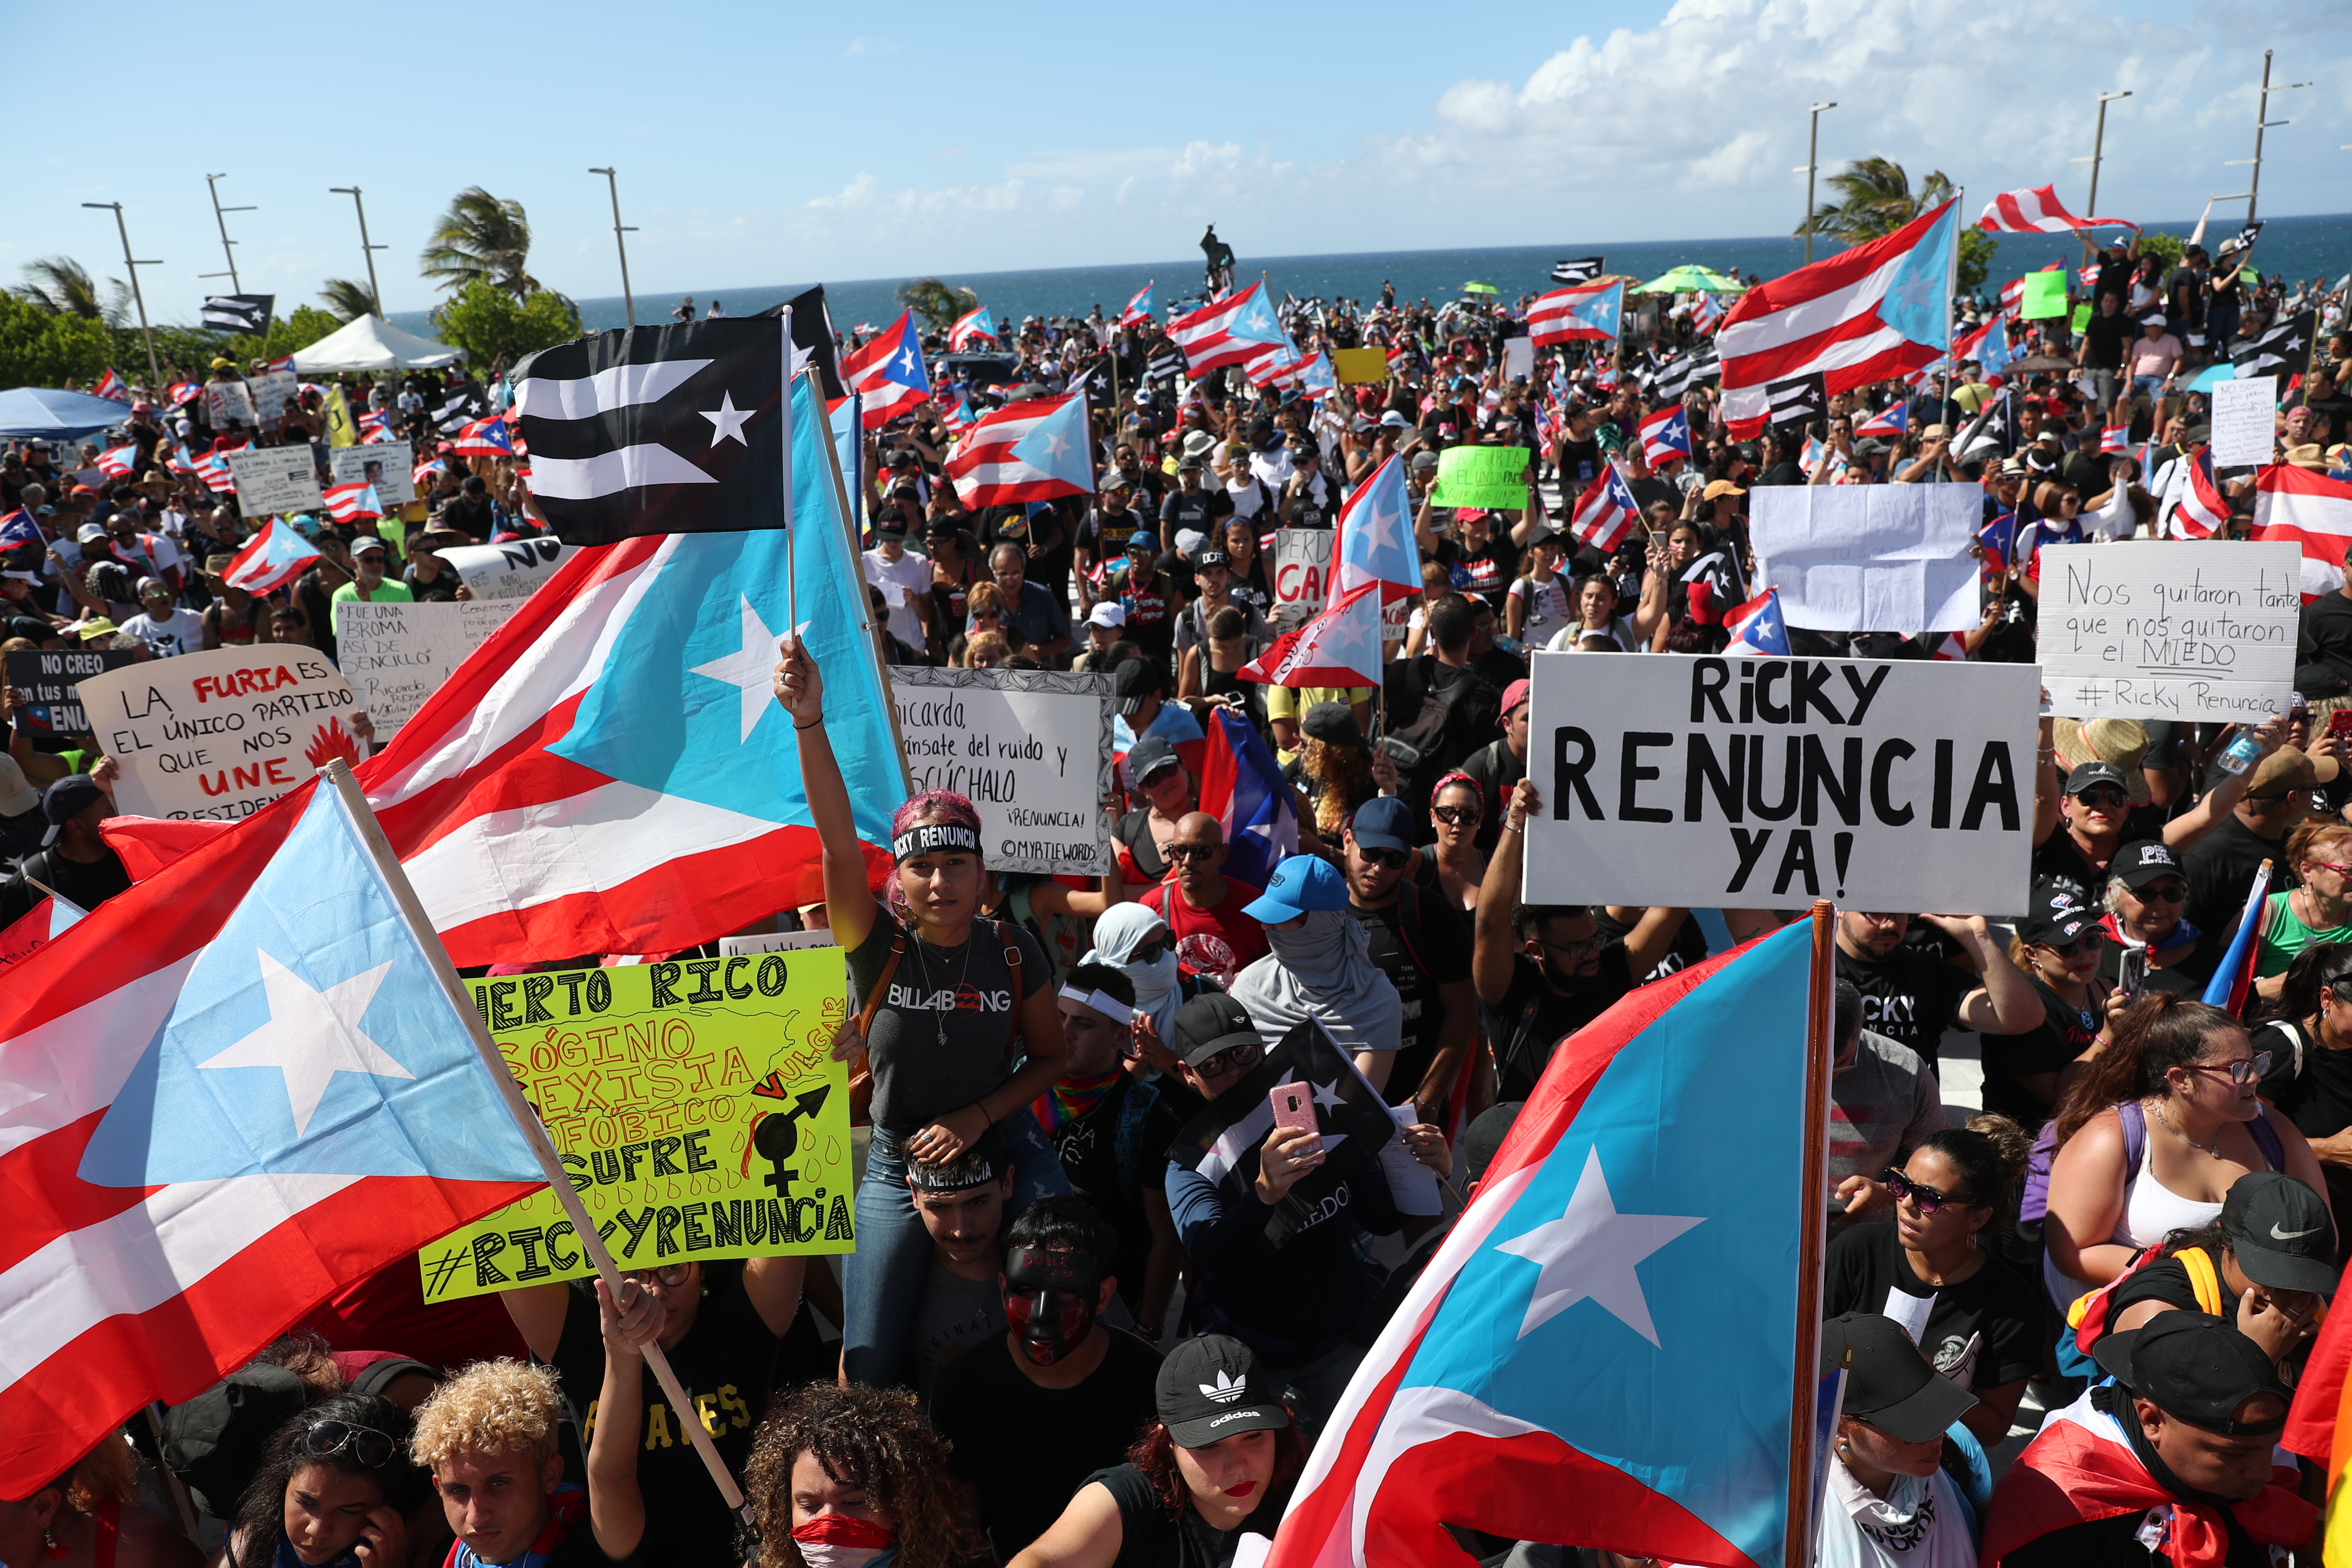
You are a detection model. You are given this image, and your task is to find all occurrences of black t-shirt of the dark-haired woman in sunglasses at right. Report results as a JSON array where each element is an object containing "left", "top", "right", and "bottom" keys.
[{"left": 1820, "top": 1220, "right": 2042, "bottom": 1389}]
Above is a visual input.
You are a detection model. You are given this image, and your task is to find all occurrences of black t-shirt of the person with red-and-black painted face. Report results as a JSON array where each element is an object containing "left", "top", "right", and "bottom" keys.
[{"left": 931, "top": 1323, "right": 1160, "bottom": 1563}]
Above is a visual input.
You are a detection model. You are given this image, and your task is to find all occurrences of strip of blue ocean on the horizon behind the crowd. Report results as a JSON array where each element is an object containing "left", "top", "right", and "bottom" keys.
[{"left": 393, "top": 214, "right": 2352, "bottom": 331}]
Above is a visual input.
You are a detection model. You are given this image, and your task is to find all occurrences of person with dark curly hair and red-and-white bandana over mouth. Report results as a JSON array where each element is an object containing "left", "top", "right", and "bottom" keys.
[{"left": 743, "top": 1382, "right": 988, "bottom": 1568}]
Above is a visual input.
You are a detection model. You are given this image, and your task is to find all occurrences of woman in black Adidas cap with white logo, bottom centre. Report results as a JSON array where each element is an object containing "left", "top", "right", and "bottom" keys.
[{"left": 1009, "top": 1335, "right": 1308, "bottom": 1568}]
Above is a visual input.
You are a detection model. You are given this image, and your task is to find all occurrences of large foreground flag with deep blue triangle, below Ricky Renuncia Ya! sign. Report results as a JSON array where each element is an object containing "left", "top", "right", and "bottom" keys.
[{"left": 1265, "top": 922, "right": 1820, "bottom": 1568}]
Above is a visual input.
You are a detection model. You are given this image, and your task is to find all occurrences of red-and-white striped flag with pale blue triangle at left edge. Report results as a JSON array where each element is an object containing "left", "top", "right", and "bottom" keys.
[{"left": 0, "top": 783, "right": 546, "bottom": 1498}]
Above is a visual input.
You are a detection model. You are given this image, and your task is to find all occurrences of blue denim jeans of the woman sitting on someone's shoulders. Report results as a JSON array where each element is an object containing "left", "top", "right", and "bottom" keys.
[{"left": 842, "top": 1105, "right": 1070, "bottom": 1387}]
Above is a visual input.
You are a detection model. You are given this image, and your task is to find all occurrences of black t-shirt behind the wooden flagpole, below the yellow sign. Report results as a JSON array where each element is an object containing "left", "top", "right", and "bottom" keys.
[{"left": 555, "top": 1260, "right": 776, "bottom": 1563}]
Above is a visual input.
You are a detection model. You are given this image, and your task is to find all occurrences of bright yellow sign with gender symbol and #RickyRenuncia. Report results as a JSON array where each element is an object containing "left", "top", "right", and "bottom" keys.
[{"left": 416, "top": 947, "right": 856, "bottom": 1302}]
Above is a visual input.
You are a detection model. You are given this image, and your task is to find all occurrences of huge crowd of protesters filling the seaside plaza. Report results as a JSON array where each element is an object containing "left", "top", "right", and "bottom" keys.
[{"left": 14, "top": 236, "right": 2352, "bottom": 1568}]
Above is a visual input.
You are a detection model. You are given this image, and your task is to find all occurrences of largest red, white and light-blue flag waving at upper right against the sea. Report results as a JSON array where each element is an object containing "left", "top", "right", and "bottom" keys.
[{"left": 1715, "top": 202, "right": 1959, "bottom": 440}]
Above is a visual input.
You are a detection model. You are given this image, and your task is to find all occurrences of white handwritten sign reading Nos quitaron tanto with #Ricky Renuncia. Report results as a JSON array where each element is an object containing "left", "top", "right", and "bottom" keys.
[{"left": 2039, "top": 538, "right": 2303, "bottom": 724}]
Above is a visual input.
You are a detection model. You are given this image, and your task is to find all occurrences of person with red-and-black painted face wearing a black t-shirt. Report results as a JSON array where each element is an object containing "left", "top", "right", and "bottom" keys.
[{"left": 931, "top": 1197, "right": 1160, "bottom": 1561}]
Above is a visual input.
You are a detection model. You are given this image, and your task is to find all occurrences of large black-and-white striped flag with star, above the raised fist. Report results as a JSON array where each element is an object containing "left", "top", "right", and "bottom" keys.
[{"left": 513, "top": 317, "right": 793, "bottom": 545}]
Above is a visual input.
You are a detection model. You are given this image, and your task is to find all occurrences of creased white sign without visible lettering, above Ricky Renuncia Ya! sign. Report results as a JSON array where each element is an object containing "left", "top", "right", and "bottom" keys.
[{"left": 1748, "top": 484, "right": 1985, "bottom": 637}]
